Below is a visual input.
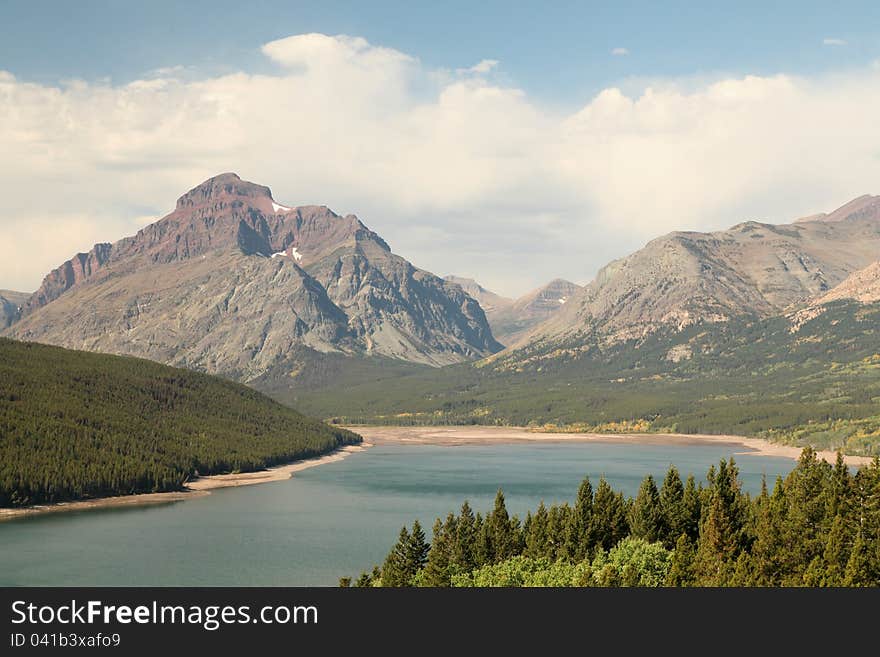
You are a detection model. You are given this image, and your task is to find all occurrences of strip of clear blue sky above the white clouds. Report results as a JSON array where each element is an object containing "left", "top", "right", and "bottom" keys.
[{"left": 0, "top": 0, "right": 880, "bottom": 103}]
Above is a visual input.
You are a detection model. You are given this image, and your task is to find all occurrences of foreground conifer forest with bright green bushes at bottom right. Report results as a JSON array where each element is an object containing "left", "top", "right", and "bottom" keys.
[{"left": 340, "top": 448, "right": 880, "bottom": 587}]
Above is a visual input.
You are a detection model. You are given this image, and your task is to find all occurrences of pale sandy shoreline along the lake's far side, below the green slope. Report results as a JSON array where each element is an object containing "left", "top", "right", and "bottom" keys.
[{"left": 346, "top": 426, "right": 871, "bottom": 467}]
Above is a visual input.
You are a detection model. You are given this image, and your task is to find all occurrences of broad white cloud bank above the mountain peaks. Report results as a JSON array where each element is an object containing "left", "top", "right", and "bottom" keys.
[{"left": 0, "top": 34, "right": 880, "bottom": 294}]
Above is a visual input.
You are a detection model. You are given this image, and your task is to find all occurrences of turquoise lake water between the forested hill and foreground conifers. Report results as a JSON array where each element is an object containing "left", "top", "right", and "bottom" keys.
[{"left": 0, "top": 443, "right": 795, "bottom": 586}]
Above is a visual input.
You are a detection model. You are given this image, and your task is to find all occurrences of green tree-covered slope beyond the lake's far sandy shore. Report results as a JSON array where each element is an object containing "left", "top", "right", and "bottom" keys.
[{"left": 278, "top": 302, "right": 880, "bottom": 455}]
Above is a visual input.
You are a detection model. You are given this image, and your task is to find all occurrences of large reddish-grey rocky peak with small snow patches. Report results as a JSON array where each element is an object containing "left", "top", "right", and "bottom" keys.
[{"left": 7, "top": 173, "right": 501, "bottom": 381}]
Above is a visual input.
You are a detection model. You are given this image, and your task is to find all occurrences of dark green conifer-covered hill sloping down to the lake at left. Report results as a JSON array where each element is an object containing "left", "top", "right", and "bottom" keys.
[{"left": 0, "top": 338, "right": 361, "bottom": 507}]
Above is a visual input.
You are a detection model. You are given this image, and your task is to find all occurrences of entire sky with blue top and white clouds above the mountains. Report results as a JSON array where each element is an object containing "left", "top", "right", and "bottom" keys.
[{"left": 0, "top": 0, "right": 880, "bottom": 296}]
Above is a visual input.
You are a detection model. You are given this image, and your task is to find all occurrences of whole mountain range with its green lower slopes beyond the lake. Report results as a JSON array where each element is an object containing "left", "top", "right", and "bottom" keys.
[{"left": 0, "top": 179, "right": 880, "bottom": 453}]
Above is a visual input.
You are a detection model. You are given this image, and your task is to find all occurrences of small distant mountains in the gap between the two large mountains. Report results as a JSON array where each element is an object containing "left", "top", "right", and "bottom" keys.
[{"left": 445, "top": 276, "right": 581, "bottom": 346}]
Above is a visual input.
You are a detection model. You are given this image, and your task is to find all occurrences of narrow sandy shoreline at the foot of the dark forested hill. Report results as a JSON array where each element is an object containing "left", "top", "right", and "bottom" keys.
[{"left": 0, "top": 440, "right": 373, "bottom": 522}]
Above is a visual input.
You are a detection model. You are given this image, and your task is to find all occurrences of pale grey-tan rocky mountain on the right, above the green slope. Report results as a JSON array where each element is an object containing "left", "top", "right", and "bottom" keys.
[{"left": 508, "top": 197, "right": 880, "bottom": 360}]
